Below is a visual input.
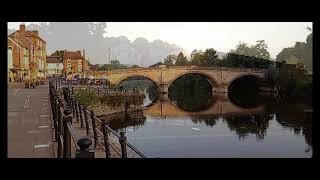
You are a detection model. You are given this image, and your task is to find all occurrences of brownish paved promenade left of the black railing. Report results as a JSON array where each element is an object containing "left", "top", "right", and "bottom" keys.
[{"left": 7, "top": 82, "right": 54, "bottom": 158}]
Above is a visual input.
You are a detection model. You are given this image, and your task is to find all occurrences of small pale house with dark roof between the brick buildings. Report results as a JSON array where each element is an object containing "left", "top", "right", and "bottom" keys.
[{"left": 47, "top": 56, "right": 63, "bottom": 77}]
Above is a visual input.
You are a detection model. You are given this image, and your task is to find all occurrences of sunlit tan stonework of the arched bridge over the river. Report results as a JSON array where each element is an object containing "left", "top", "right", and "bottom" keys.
[{"left": 87, "top": 66, "right": 265, "bottom": 93}]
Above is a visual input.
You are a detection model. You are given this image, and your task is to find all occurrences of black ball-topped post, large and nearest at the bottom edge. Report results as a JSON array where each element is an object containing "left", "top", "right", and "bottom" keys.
[{"left": 76, "top": 137, "right": 94, "bottom": 158}]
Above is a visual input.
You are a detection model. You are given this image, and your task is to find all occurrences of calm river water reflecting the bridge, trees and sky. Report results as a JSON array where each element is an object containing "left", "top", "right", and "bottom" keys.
[{"left": 110, "top": 78, "right": 312, "bottom": 158}]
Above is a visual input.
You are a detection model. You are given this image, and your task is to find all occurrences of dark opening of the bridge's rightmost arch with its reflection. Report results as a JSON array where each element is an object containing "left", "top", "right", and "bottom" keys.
[{"left": 228, "top": 74, "right": 263, "bottom": 108}]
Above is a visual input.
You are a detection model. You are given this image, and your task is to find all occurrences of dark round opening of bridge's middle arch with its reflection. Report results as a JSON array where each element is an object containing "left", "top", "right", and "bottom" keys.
[{"left": 168, "top": 73, "right": 215, "bottom": 112}]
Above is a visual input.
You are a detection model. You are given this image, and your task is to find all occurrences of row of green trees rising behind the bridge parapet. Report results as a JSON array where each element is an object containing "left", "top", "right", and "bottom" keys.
[{"left": 150, "top": 40, "right": 274, "bottom": 69}]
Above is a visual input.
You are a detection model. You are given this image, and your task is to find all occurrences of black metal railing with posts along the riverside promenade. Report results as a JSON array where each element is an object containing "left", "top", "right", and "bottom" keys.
[{"left": 49, "top": 78, "right": 146, "bottom": 158}]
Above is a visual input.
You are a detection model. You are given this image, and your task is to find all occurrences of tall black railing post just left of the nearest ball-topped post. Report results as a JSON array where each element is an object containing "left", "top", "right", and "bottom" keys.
[{"left": 63, "top": 109, "right": 72, "bottom": 158}]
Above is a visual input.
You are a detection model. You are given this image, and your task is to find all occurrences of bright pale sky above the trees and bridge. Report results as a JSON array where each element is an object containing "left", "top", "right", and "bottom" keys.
[{"left": 8, "top": 22, "right": 312, "bottom": 58}]
